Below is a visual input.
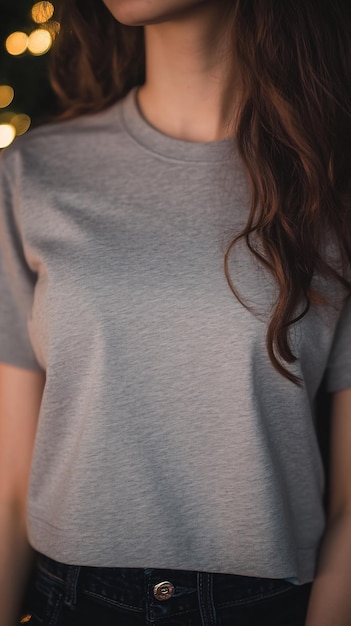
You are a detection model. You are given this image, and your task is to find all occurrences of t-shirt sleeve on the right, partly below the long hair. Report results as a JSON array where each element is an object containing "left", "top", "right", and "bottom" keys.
[{"left": 327, "top": 296, "right": 351, "bottom": 392}]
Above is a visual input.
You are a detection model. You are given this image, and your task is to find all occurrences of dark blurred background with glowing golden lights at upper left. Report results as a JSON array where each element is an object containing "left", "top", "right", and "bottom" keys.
[{"left": 0, "top": 0, "right": 60, "bottom": 149}]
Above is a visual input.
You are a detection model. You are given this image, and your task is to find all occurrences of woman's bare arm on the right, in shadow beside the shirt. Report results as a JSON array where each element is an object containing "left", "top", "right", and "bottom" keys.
[{"left": 306, "top": 389, "right": 351, "bottom": 626}]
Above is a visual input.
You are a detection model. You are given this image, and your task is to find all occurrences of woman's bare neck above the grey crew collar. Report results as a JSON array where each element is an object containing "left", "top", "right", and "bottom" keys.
[{"left": 138, "top": 2, "right": 239, "bottom": 142}]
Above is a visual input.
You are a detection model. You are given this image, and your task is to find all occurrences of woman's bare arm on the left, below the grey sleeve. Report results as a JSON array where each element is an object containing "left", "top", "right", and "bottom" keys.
[{"left": 0, "top": 363, "right": 45, "bottom": 626}]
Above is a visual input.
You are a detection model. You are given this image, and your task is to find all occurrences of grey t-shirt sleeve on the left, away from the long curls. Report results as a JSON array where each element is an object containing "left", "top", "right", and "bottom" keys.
[{"left": 0, "top": 155, "right": 42, "bottom": 371}]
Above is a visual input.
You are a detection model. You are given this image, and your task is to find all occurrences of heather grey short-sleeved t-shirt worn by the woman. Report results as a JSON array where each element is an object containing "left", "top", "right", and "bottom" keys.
[{"left": 0, "top": 89, "right": 351, "bottom": 583}]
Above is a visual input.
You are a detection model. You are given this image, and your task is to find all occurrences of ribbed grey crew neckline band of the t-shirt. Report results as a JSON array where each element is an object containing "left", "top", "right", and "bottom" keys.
[{"left": 121, "top": 86, "right": 236, "bottom": 162}]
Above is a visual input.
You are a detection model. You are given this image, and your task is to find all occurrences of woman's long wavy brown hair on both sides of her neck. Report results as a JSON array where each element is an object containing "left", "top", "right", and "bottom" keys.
[{"left": 52, "top": 0, "right": 351, "bottom": 384}]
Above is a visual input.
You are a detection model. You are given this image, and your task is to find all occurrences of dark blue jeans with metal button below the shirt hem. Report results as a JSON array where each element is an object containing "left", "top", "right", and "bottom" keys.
[{"left": 30, "top": 555, "right": 311, "bottom": 626}]
